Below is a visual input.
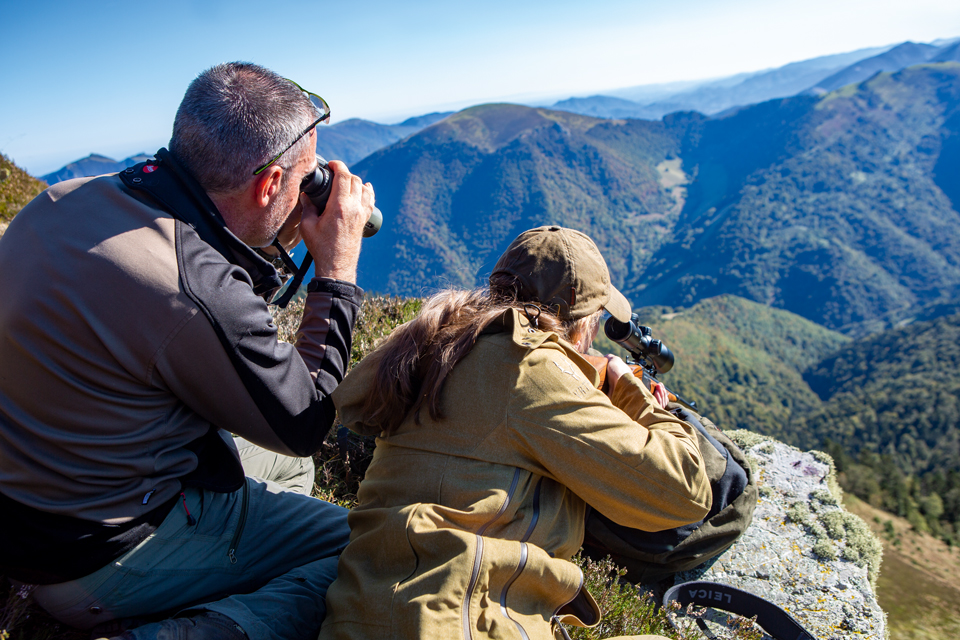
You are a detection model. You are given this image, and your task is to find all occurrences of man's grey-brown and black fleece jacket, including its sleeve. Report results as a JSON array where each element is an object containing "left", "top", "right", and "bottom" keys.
[{"left": 0, "top": 152, "right": 362, "bottom": 584}]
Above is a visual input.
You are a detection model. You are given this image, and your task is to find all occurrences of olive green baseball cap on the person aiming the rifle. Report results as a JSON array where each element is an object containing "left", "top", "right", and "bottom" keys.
[{"left": 491, "top": 226, "right": 631, "bottom": 322}]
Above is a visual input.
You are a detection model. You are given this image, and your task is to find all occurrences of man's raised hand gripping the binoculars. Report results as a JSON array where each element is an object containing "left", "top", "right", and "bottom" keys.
[{"left": 300, "top": 160, "right": 374, "bottom": 282}]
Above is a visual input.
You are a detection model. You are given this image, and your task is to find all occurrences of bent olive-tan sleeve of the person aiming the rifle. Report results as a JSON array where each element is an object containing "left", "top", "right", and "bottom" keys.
[{"left": 507, "top": 348, "right": 712, "bottom": 531}]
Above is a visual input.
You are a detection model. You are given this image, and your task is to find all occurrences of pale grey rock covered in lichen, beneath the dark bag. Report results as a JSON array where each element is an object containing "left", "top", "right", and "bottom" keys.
[{"left": 675, "top": 431, "right": 886, "bottom": 640}]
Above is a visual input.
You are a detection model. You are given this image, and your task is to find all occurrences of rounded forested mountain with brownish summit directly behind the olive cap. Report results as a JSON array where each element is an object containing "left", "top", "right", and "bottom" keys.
[{"left": 356, "top": 104, "right": 681, "bottom": 295}]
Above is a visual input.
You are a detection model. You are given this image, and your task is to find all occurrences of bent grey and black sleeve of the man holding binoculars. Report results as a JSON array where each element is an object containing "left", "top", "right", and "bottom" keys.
[{"left": 156, "top": 279, "right": 362, "bottom": 456}]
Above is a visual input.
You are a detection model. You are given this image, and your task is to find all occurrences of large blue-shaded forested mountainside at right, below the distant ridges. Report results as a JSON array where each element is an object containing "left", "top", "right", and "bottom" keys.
[{"left": 626, "top": 63, "right": 960, "bottom": 334}]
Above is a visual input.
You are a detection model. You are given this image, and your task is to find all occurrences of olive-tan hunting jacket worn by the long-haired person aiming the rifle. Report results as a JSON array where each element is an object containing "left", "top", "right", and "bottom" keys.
[{"left": 320, "top": 311, "right": 711, "bottom": 640}]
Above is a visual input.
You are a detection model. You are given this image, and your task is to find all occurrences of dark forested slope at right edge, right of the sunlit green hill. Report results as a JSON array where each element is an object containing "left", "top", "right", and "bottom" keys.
[{"left": 804, "top": 313, "right": 960, "bottom": 543}]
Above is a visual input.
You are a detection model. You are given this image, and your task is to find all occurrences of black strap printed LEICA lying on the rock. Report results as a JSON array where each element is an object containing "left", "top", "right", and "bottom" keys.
[{"left": 663, "top": 581, "right": 817, "bottom": 640}]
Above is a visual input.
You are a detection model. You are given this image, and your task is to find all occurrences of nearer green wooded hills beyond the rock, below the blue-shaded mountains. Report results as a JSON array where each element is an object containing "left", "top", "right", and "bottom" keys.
[{"left": 616, "top": 296, "right": 960, "bottom": 544}]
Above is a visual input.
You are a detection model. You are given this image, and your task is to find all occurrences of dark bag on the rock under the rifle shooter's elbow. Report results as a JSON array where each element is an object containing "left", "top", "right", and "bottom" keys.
[{"left": 583, "top": 403, "right": 758, "bottom": 584}]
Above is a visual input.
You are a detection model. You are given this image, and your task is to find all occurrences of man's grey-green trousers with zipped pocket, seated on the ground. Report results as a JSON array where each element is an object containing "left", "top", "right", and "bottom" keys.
[{"left": 26, "top": 440, "right": 350, "bottom": 640}]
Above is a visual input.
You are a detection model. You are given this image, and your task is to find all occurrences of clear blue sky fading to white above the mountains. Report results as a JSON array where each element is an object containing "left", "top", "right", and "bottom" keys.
[{"left": 0, "top": 0, "right": 960, "bottom": 175}]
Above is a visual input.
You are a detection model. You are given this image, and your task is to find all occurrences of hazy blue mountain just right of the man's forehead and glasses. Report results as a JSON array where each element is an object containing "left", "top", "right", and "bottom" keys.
[{"left": 317, "top": 112, "right": 450, "bottom": 165}]
